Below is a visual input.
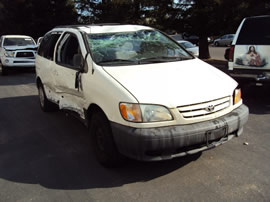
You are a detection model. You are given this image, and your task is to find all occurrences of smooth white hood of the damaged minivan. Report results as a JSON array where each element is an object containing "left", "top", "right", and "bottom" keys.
[{"left": 104, "top": 59, "right": 237, "bottom": 108}]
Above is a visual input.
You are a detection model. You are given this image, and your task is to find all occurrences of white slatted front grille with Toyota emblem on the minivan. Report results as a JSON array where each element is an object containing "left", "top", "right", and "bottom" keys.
[{"left": 178, "top": 96, "right": 230, "bottom": 119}]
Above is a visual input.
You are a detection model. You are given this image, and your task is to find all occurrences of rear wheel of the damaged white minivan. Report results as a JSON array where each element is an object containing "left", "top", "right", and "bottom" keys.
[{"left": 38, "top": 83, "right": 59, "bottom": 112}]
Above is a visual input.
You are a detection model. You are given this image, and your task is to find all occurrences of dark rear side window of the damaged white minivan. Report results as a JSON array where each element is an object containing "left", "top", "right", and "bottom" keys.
[{"left": 38, "top": 32, "right": 61, "bottom": 60}]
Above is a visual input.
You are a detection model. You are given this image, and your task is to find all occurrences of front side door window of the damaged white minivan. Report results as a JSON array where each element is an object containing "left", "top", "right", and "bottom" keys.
[{"left": 56, "top": 33, "right": 81, "bottom": 69}]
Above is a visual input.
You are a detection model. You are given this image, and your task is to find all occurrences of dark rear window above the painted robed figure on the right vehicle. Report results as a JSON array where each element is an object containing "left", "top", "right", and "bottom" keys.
[{"left": 236, "top": 16, "right": 270, "bottom": 45}]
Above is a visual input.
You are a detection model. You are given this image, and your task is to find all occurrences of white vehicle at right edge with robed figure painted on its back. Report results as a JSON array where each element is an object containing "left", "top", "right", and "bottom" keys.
[{"left": 228, "top": 15, "right": 270, "bottom": 82}]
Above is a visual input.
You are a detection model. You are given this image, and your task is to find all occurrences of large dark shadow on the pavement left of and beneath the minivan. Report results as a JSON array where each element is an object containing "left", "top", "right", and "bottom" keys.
[{"left": 0, "top": 96, "right": 200, "bottom": 190}]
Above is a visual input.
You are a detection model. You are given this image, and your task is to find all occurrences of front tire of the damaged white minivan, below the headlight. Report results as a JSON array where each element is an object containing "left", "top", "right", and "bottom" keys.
[{"left": 89, "top": 111, "right": 124, "bottom": 168}]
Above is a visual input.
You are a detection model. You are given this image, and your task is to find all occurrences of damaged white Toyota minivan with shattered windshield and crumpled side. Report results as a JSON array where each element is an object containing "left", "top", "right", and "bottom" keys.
[{"left": 36, "top": 25, "right": 249, "bottom": 166}]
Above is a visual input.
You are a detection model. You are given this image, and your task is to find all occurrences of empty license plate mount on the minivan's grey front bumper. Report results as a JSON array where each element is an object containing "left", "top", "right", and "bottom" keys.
[{"left": 205, "top": 126, "right": 228, "bottom": 147}]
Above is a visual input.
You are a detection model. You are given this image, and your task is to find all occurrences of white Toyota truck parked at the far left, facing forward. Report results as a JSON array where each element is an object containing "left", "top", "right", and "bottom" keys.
[{"left": 0, "top": 35, "right": 37, "bottom": 75}]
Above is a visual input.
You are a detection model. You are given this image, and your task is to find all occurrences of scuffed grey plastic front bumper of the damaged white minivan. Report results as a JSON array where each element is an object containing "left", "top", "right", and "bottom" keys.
[{"left": 111, "top": 104, "right": 249, "bottom": 161}]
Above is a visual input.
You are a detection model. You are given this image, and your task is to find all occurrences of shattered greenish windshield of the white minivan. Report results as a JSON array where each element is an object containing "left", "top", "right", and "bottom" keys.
[{"left": 88, "top": 30, "right": 194, "bottom": 66}]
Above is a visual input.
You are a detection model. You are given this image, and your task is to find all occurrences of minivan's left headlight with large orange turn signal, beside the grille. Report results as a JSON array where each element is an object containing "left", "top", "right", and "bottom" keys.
[{"left": 120, "top": 103, "right": 173, "bottom": 123}]
